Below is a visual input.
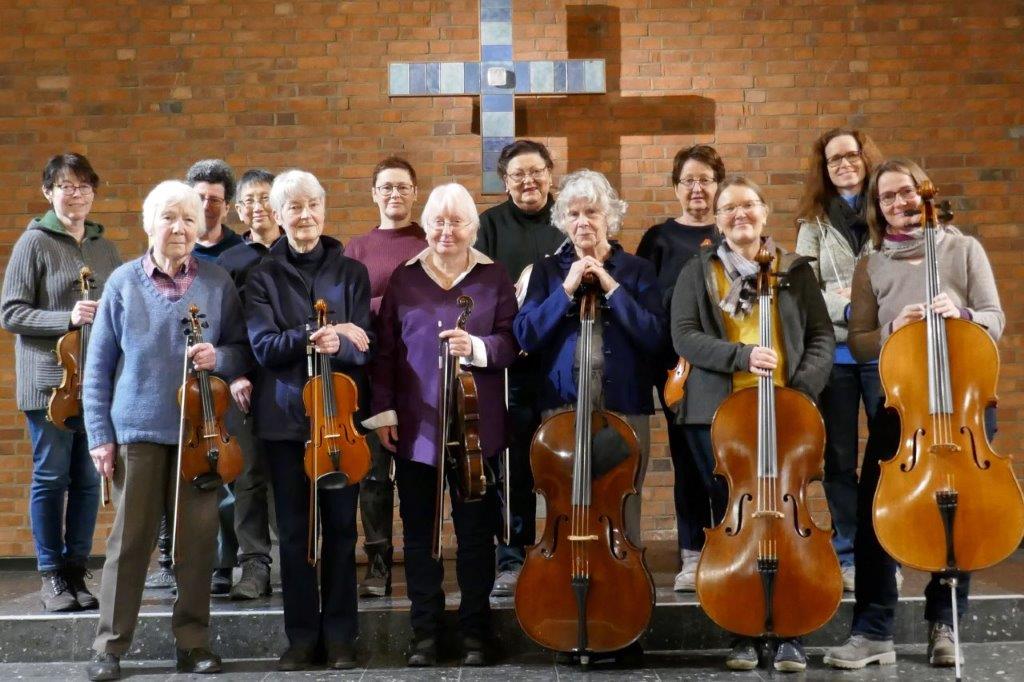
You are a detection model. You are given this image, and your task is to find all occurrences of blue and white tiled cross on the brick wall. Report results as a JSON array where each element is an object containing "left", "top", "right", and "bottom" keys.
[{"left": 388, "top": 0, "right": 605, "bottom": 195}]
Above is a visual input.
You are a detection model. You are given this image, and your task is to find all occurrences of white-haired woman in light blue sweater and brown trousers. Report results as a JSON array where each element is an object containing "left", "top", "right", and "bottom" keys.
[{"left": 82, "top": 180, "right": 252, "bottom": 680}]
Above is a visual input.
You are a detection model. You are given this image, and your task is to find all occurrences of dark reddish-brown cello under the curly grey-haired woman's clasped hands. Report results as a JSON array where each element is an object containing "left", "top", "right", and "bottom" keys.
[{"left": 515, "top": 275, "right": 654, "bottom": 665}]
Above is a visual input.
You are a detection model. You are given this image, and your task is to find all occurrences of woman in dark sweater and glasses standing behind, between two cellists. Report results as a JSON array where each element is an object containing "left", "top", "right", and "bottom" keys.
[{"left": 637, "top": 144, "right": 725, "bottom": 592}]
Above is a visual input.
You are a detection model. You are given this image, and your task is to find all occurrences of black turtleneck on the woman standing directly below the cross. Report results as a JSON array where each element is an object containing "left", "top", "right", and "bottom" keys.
[{"left": 473, "top": 195, "right": 565, "bottom": 282}]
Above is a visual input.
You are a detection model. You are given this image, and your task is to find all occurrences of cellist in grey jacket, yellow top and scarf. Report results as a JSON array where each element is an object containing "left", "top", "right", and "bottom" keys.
[{"left": 672, "top": 176, "right": 836, "bottom": 672}]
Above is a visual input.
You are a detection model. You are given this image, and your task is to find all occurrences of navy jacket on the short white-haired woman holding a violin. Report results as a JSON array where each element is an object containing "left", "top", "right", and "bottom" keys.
[{"left": 245, "top": 237, "right": 376, "bottom": 441}]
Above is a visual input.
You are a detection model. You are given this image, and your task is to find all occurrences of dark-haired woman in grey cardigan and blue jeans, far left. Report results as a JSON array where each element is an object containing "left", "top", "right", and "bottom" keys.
[{"left": 2, "top": 154, "right": 121, "bottom": 611}]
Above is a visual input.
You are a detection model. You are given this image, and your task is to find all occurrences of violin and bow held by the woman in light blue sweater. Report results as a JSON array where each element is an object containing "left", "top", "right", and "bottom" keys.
[{"left": 171, "top": 304, "right": 242, "bottom": 562}]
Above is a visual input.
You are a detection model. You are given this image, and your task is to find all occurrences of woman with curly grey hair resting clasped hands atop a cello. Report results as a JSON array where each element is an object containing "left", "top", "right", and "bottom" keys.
[{"left": 515, "top": 170, "right": 668, "bottom": 545}]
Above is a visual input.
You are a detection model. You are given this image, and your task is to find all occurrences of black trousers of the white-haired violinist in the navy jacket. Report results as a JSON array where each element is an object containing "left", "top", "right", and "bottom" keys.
[{"left": 263, "top": 440, "right": 359, "bottom": 646}]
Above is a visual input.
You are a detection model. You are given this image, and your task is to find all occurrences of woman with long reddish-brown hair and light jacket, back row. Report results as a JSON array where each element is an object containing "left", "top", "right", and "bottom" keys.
[{"left": 797, "top": 128, "right": 882, "bottom": 591}]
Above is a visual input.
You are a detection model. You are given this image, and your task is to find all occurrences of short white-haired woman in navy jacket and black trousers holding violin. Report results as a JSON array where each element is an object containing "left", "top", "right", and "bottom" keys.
[{"left": 245, "top": 170, "right": 374, "bottom": 671}]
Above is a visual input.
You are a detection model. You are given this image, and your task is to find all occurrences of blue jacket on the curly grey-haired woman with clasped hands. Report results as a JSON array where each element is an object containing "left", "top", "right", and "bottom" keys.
[{"left": 513, "top": 242, "right": 668, "bottom": 415}]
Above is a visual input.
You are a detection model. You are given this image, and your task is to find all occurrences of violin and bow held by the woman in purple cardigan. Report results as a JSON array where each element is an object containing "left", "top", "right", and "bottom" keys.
[{"left": 432, "top": 296, "right": 487, "bottom": 559}]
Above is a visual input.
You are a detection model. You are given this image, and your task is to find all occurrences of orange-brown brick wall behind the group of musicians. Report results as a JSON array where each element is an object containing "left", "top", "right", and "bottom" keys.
[{"left": 0, "top": 0, "right": 1024, "bottom": 556}]
